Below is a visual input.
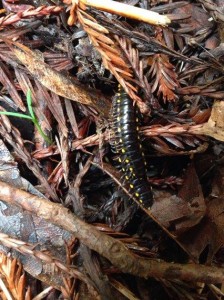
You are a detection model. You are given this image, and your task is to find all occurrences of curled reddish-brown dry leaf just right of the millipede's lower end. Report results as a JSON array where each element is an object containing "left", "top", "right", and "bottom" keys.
[{"left": 151, "top": 165, "right": 206, "bottom": 235}]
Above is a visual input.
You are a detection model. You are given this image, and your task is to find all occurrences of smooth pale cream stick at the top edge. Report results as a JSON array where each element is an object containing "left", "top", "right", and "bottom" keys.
[{"left": 81, "top": 0, "right": 171, "bottom": 26}]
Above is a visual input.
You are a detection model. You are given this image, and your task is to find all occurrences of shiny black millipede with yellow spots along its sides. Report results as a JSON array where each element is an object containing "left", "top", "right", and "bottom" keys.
[{"left": 112, "top": 86, "right": 153, "bottom": 209}]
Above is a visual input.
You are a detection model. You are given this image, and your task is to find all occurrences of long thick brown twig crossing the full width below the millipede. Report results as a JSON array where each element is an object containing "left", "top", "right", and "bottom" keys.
[{"left": 0, "top": 182, "right": 224, "bottom": 283}]
